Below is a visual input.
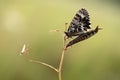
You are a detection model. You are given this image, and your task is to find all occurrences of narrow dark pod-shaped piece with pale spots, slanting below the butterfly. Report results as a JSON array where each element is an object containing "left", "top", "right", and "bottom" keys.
[{"left": 66, "top": 26, "right": 100, "bottom": 47}]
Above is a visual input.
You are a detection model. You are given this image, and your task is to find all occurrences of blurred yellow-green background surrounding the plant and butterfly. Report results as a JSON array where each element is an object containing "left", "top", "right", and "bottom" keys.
[{"left": 0, "top": 0, "right": 120, "bottom": 80}]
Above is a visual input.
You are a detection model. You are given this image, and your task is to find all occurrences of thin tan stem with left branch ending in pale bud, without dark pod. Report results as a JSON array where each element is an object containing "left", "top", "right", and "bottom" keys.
[{"left": 20, "top": 27, "right": 67, "bottom": 80}]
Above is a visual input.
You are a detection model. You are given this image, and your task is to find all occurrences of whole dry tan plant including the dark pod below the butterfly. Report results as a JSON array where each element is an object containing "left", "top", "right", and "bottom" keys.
[{"left": 20, "top": 23, "right": 102, "bottom": 80}]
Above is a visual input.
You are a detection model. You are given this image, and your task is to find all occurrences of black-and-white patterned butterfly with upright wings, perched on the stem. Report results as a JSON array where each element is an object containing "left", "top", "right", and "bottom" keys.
[{"left": 65, "top": 8, "right": 91, "bottom": 38}]
